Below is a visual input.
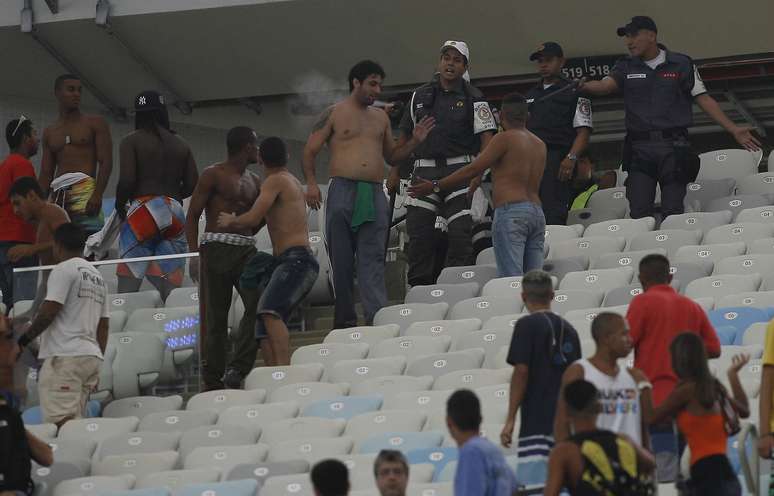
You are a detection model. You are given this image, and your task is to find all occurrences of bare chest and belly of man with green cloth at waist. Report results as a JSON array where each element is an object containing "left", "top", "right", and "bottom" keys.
[{"left": 328, "top": 100, "right": 389, "bottom": 182}]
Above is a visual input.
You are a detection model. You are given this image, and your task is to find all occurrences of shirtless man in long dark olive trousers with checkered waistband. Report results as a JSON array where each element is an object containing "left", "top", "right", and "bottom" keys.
[{"left": 185, "top": 126, "right": 261, "bottom": 390}]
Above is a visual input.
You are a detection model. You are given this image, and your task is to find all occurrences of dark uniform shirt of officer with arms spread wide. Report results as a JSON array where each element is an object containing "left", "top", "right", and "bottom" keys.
[{"left": 607, "top": 46, "right": 707, "bottom": 132}]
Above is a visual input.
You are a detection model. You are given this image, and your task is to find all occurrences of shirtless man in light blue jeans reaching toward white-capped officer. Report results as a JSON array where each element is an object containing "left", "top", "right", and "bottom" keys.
[{"left": 409, "top": 93, "right": 546, "bottom": 277}]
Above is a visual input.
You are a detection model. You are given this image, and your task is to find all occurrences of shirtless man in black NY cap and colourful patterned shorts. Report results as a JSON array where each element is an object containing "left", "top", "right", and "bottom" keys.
[{"left": 116, "top": 91, "right": 199, "bottom": 299}]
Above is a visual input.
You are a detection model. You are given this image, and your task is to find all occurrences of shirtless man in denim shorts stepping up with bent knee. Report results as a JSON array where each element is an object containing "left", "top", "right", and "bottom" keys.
[{"left": 218, "top": 137, "right": 320, "bottom": 366}]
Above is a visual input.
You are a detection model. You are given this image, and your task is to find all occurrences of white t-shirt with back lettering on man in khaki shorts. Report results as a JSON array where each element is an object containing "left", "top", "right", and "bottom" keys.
[{"left": 38, "top": 257, "right": 109, "bottom": 358}]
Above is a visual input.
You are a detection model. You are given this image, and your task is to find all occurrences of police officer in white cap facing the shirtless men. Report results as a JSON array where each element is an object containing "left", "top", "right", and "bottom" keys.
[{"left": 398, "top": 41, "right": 497, "bottom": 286}]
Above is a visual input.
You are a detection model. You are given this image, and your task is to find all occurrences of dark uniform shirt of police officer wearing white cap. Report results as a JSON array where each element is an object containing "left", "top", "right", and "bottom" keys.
[{"left": 399, "top": 80, "right": 497, "bottom": 159}]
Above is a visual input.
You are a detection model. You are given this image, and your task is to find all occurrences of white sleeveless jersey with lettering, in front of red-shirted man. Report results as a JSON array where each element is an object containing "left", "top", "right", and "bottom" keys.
[{"left": 576, "top": 358, "right": 642, "bottom": 445}]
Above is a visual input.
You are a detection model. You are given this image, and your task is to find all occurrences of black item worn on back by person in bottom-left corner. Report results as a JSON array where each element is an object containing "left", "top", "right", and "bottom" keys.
[{"left": 0, "top": 403, "right": 34, "bottom": 494}]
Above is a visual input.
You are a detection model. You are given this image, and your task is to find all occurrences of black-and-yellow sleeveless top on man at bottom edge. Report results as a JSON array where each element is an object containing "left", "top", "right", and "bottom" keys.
[{"left": 570, "top": 430, "right": 656, "bottom": 496}]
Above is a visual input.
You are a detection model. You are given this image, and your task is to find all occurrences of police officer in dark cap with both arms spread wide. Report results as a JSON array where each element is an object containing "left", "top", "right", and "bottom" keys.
[{"left": 580, "top": 16, "right": 760, "bottom": 219}]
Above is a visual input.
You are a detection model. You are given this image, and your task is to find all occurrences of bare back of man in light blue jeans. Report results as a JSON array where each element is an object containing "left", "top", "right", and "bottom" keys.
[{"left": 490, "top": 128, "right": 546, "bottom": 208}]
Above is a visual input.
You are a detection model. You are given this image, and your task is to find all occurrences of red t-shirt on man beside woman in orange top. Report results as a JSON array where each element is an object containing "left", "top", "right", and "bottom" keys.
[{"left": 626, "top": 284, "right": 720, "bottom": 405}]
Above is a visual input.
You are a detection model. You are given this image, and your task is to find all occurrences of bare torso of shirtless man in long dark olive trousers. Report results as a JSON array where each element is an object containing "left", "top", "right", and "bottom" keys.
[{"left": 202, "top": 163, "right": 261, "bottom": 236}]
